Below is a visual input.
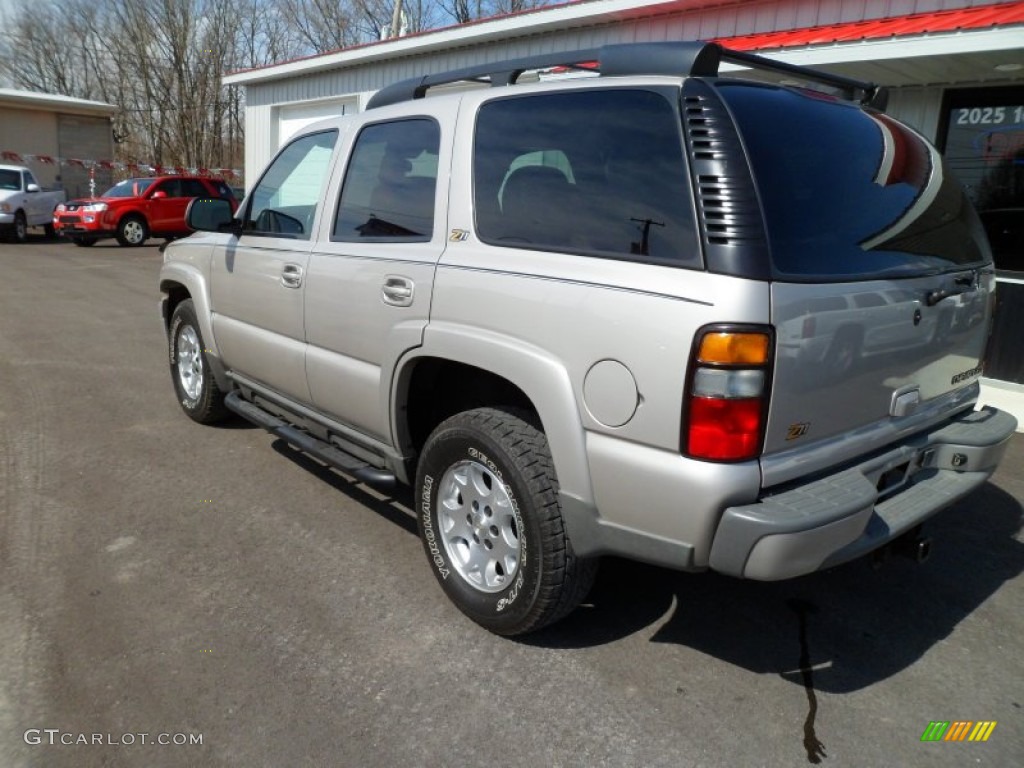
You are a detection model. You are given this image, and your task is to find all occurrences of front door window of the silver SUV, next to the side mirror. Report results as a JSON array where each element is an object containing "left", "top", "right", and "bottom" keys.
[{"left": 244, "top": 131, "right": 338, "bottom": 240}]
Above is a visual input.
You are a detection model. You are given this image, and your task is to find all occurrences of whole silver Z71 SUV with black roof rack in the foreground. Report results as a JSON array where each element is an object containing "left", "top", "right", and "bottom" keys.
[{"left": 160, "top": 43, "right": 1016, "bottom": 635}]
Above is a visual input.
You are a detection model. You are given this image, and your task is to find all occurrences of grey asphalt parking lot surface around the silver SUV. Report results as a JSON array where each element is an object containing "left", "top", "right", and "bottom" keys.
[{"left": 0, "top": 239, "right": 1024, "bottom": 768}]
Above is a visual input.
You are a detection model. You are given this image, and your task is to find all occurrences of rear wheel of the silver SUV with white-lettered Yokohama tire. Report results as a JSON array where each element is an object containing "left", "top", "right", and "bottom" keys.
[{"left": 416, "top": 408, "right": 597, "bottom": 635}]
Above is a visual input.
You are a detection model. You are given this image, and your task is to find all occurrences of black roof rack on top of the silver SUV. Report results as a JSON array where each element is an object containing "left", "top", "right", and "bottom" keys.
[{"left": 367, "top": 41, "right": 886, "bottom": 110}]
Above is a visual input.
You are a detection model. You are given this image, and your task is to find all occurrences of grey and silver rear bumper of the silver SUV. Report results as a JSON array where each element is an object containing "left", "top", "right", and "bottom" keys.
[{"left": 710, "top": 408, "right": 1017, "bottom": 581}]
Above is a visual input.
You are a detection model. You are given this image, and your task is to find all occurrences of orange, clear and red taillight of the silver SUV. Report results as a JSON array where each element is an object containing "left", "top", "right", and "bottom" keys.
[{"left": 682, "top": 327, "right": 772, "bottom": 461}]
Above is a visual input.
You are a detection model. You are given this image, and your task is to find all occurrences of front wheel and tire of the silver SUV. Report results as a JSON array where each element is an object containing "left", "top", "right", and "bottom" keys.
[{"left": 167, "top": 299, "right": 227, "bottom": 424}]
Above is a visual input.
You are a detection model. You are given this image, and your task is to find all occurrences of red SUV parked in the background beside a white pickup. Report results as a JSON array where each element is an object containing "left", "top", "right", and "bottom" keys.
[{"left": 53, "top": 176, "right": 239, "bottom": 246}]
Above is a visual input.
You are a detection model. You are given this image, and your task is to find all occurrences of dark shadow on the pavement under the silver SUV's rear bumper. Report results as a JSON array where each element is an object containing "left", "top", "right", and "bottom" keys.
[{"left": 522, "top": 483, "right": 1024, "bottom": 692}]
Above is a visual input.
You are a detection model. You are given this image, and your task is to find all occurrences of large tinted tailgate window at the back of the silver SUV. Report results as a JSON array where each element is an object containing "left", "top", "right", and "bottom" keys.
[{"left": 719, "top": 82, "right": 991, "bottom": 281}]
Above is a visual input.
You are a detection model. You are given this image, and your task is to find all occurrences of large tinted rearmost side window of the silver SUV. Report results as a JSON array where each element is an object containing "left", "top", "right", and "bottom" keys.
[{"left": 473, "top": 89, "right": 700, "bottom": 266}]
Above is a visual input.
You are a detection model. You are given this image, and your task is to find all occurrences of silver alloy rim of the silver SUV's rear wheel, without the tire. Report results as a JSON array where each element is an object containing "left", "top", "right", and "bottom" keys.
[{"left": 437, "top": 461, "right": 521, "bottom": 593}]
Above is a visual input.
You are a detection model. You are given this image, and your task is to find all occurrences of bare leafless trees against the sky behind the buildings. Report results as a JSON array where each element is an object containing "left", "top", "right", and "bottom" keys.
[{"left": 0, "top": 0, "right": 561, "bottom": 174}]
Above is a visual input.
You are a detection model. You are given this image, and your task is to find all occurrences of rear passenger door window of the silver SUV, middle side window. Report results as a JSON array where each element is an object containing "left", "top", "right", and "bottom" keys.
[{"left": 333, "top": 119, "right": 440, "bottom": 242}]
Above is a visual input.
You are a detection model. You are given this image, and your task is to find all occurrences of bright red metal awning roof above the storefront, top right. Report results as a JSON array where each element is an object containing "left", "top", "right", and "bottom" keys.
[{"left": 717, "top": 0, "right": 1024, "bottom": 50}]
